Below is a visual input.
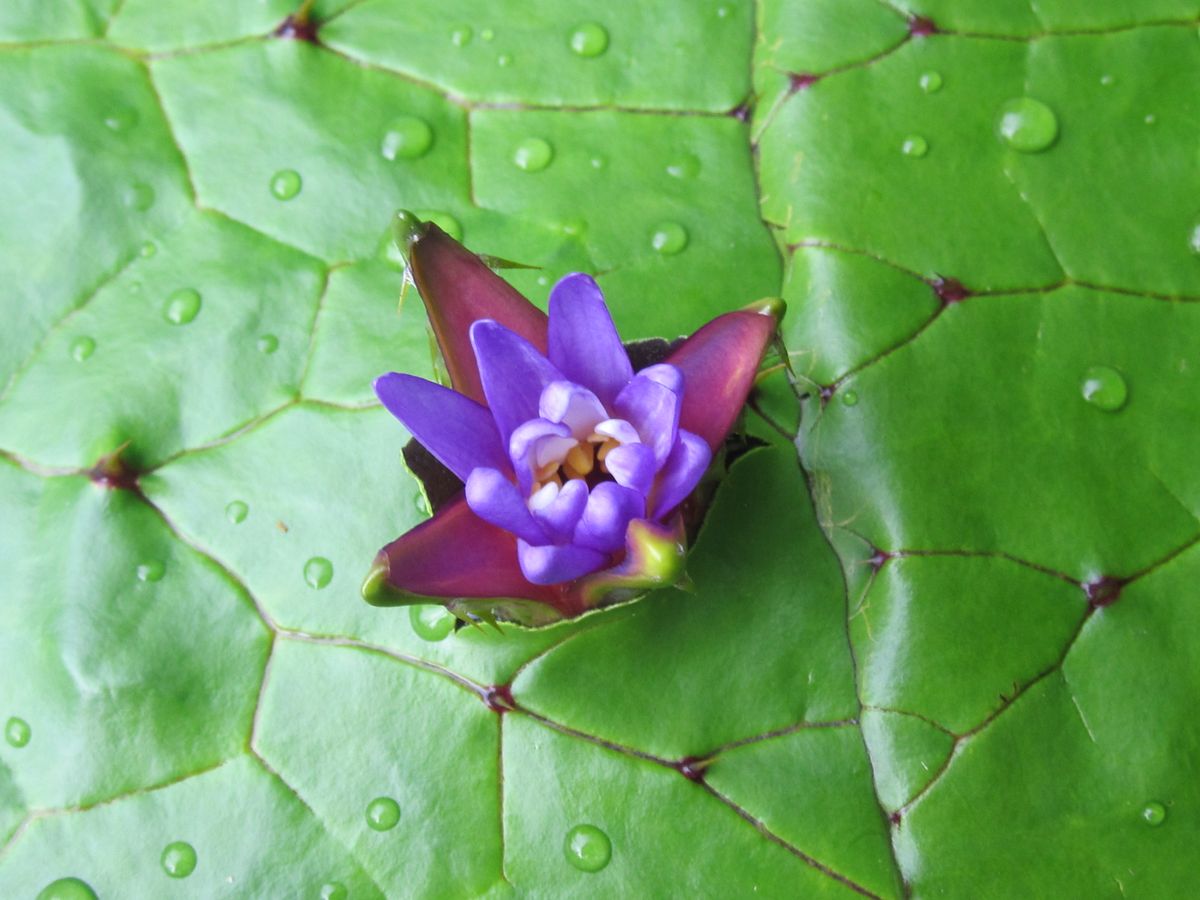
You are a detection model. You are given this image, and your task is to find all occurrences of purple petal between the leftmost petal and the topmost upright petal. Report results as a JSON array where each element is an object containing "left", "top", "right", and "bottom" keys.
[{"left": 470, "top": 319, "right": 563, "bottom": 442}]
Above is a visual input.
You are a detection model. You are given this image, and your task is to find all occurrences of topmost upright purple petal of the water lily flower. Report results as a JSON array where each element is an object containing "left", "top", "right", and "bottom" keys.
[{"left": 550, "top": 272, "right": 634, "bottom": 404}]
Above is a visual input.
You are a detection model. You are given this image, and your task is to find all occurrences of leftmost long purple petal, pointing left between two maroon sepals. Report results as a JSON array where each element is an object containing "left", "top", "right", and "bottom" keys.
[{"left": 374, "top": 372, "right": 511, "bottom": 481}]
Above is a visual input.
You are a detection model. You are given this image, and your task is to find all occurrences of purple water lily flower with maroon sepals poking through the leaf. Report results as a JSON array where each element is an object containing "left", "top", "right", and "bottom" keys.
[{"left": 364, "top": 214, "right": 781, "bottom": 624}]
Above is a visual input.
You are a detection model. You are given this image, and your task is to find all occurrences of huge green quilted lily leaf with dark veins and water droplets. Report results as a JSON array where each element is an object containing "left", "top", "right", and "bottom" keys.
[{"left": 0, "top": 0, "right": 1200, "bottom": 899}]
